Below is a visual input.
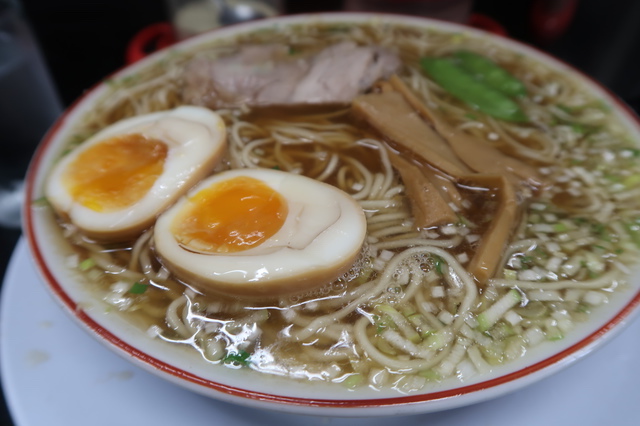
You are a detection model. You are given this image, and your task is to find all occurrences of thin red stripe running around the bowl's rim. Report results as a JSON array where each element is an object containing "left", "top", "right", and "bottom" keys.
[{"left": 23, "top": 13, "right": 640, "bottom": 408}]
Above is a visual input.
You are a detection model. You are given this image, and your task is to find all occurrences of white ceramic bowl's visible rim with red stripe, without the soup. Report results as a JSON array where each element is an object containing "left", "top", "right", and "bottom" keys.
[{"left": 24, "top": 14, "right": 640, "bottom": 416}]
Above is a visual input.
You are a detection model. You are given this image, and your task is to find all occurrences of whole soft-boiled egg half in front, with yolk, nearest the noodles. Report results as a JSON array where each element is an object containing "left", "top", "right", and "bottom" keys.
[{"left": 154, "top": 169, "right": 366, "bottom": 297}]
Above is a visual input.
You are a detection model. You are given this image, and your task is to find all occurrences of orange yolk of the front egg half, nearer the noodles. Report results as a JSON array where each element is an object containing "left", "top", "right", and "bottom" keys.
[{"left": 171, "top": 176, "right": 288, "bottom": 253}]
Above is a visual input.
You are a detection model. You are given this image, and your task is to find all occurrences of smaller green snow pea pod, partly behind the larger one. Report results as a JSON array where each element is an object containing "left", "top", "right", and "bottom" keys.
[{"left": 454, "top": 50, "right": 527, "bottom": 96}]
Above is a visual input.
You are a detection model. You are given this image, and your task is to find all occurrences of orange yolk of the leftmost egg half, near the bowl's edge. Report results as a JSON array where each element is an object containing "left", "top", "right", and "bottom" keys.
[{"left": 63, "top": 133, "right": 168, "bottom": 212}]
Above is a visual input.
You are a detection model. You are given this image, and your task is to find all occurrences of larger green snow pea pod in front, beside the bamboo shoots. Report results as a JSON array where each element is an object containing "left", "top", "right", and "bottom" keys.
[{"left": 420, "top": 58, "right": 528, "bottom": 122}]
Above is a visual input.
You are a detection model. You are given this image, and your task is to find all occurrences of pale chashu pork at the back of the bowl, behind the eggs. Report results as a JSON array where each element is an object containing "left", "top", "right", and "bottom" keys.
[{"left": 182, "top": 42, "right": 401, "bottom": 109}]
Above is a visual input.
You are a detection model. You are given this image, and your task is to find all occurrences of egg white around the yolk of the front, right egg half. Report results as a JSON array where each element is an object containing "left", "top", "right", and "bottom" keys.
[{"left": 154, "top": 169, "right": 367, "bottom": 298}]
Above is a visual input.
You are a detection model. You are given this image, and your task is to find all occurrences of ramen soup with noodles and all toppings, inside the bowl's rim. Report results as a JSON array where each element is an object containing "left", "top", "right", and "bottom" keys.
[{"left": 38, "top": 24, "right": 640, "bottom": 392}]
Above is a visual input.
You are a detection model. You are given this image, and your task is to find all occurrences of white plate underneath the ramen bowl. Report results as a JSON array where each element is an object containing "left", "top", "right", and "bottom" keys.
[{"left": 0, "top": 236, "right": 640, "bottom": 426}]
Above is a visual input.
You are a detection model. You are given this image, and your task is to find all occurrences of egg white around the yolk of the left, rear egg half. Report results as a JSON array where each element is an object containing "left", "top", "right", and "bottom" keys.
[{"left": 45, "top": 106, "right": 226, "bottom": 241}]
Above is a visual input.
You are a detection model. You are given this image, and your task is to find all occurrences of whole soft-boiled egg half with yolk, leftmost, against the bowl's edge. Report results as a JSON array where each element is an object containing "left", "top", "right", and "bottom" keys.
[{"left": 45, "top": 106, "right": 226, "bottom": 241}]
